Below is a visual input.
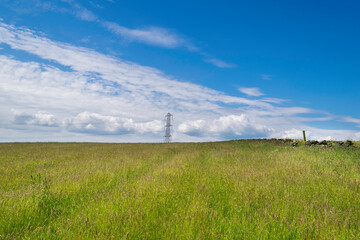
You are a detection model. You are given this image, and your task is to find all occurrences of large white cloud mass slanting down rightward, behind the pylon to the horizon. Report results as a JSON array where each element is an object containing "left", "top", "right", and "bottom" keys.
[{"left": 0, "top": 23, "right": 360, "bottom": 142}]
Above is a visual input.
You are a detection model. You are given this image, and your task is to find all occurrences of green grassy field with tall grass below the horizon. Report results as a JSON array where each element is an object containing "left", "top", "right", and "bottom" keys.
[{"left": 0, "top": 140, "right": 360, "bottom": 239}]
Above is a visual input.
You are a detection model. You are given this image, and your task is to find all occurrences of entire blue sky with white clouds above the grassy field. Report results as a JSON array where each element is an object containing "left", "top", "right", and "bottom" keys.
[{"left": 0, "top": 0, "right": 360, "bottom": 142}]
